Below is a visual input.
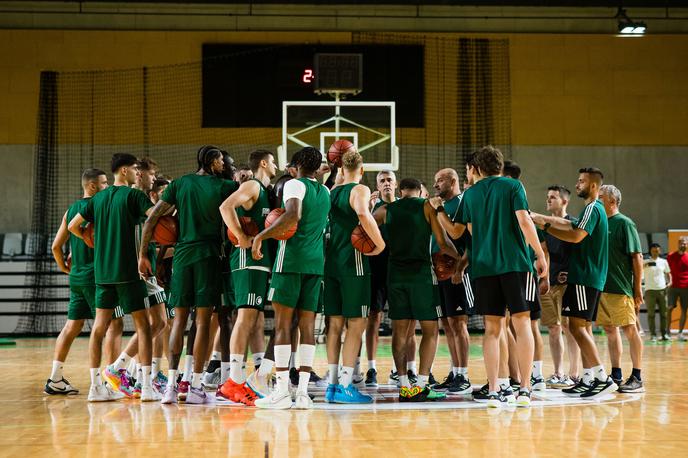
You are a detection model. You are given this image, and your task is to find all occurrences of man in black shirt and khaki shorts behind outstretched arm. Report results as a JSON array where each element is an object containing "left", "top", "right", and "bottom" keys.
[{"left": 540, "top": 185, "right": 581, "bottom": 388}]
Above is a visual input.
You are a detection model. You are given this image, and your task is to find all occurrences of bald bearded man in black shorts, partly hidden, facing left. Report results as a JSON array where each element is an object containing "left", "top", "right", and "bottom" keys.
[{"left": 432, "top": 169, "right": 472, "bottom": 394}]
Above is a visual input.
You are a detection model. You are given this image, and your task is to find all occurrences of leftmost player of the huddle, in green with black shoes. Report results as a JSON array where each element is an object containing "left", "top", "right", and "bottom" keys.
[{"left": 43, "top": 169, "right": 108, "bottom": 394}]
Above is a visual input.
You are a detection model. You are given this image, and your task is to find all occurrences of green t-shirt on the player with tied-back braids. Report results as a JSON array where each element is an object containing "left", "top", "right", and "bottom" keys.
[{"left": 162, "top": 173, "right": 239, "bottom": 267}]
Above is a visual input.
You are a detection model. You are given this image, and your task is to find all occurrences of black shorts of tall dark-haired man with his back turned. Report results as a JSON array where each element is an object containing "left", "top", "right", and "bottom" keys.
[{"left": 474, "top": 272, "right": 530, "bottom": 316}]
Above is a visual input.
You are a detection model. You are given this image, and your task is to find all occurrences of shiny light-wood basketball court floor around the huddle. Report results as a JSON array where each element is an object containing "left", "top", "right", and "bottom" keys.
[{"left": 0, "top": 336, "right": 688, "bottom": 457}]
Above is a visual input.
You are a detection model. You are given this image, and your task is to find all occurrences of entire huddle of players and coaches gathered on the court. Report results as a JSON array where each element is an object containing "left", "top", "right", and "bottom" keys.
[{"left": 45, "top": 146, "right": 643, "bottom": 409}]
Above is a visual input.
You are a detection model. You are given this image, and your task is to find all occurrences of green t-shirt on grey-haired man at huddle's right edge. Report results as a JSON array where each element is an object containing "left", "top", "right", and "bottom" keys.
[{"left": 604, "top": 213, "right": 643, "bottom": 297}]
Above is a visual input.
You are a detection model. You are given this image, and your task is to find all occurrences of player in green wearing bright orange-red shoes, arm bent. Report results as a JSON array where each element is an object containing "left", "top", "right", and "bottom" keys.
[{"left": 219, "top": 150, "right": 277, "bottom": 406}]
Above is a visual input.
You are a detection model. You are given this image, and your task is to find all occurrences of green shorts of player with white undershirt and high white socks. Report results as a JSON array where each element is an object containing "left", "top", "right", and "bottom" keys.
[{"left": 268, "top": 272, "right": 322, "bottom": 313}]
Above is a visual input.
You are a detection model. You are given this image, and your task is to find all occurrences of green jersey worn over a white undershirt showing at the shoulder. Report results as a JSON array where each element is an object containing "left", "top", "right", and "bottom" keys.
[{"left": 272, "top": 178, "right": 330, "bottom": 275}]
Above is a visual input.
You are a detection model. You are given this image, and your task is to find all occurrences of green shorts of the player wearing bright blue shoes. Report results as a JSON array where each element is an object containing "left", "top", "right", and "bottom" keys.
[{"left": 323, "top": 275, "right": 371, "bottom": 318}]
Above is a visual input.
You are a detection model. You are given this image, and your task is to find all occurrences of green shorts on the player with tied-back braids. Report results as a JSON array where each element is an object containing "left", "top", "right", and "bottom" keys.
[{"left": 169, "top": 257, "right": 222, "bottom": 308}]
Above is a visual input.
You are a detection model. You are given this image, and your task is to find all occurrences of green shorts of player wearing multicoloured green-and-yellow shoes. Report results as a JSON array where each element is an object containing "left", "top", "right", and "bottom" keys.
[{"left": 387, "top": 282, "right": 442, "bottom": 321}]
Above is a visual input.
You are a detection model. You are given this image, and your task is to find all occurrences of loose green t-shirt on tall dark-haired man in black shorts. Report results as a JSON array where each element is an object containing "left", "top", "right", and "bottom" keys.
[{"left": 458, "top": 176, "right": 532, "bottom": 278}]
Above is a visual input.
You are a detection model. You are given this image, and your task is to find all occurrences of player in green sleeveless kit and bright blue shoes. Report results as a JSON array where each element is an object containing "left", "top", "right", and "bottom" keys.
[{"left": 323, "top": 150, "right": 385, "bottom": 404}]
